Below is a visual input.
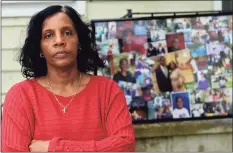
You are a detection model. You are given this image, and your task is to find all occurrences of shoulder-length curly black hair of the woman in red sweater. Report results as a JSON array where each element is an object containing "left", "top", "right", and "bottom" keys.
[{"left": 19, "top": 5, "right": 105, "bottom": 78}]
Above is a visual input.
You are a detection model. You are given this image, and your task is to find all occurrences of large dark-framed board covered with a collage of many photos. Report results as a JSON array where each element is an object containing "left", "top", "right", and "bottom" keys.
[{"left": 94, "top": 15, "right": 232, "bottom": 121}]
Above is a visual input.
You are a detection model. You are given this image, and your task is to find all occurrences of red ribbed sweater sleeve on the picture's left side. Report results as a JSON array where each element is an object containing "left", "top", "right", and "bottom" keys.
[{"left": 2, "top": 84, "right": 32, "bottom": 152}]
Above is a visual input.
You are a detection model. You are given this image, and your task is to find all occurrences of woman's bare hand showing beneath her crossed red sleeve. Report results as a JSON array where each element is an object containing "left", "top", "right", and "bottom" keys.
[{"left": 29, "top": 140, "right": 50, "bottom": 152}]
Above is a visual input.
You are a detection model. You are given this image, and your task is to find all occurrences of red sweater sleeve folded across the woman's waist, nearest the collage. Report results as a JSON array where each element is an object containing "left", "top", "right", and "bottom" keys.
[{"left": 48, "top": 80, "right": 135, "bottom": 152}]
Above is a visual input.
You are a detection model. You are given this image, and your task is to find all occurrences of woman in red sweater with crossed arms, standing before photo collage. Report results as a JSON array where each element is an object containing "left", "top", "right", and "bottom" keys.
[{"left": 2, "top": 5, "right": 135, "bottom": 152}]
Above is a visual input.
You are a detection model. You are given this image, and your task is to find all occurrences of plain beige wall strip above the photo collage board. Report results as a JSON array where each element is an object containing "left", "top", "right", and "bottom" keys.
[{"left": 87, "top": 0, "right": 214, "bottom": 19}]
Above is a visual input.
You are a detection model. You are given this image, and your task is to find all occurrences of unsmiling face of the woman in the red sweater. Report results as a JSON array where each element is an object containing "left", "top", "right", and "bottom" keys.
[{"left": 41, "top": 12, "right": 79, "bottom": 68}]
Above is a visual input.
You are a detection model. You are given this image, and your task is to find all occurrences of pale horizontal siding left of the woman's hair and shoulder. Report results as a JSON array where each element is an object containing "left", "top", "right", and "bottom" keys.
[{"left": 1, "top": 17, "right": 29, "bottom": 104}]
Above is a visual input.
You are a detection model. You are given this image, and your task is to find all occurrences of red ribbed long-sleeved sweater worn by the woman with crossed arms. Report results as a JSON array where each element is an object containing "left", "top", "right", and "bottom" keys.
[{"left": 2, "top": 76, "right": 135, "bottom": 152}]
